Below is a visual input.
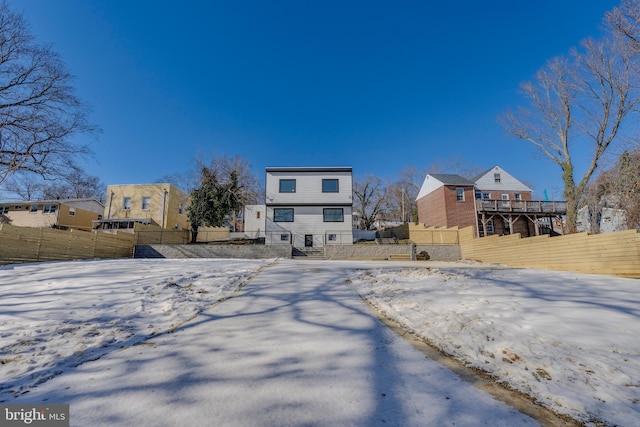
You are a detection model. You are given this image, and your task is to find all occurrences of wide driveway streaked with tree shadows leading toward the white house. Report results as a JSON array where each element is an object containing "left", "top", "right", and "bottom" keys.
[{"left": 18, "top": 260, "right": 537, "bottom": 426}]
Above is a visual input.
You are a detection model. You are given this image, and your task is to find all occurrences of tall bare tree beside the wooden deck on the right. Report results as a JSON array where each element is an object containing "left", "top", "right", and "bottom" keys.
[{"left": 502, "top": 31, "right": 639, "bottom": 233}]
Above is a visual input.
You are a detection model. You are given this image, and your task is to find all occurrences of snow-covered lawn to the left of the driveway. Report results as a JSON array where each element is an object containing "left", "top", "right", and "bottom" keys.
[{"left": 0, "top": 259, "right": 268, "bottom": 401}]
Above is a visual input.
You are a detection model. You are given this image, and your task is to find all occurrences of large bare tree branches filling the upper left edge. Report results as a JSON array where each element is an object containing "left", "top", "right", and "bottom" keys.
[{"left": 0, "top": 0, "right": 97, "bottom": 184}]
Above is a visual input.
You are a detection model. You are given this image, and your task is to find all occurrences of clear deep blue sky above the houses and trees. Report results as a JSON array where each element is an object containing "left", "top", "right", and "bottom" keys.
[{"left": 17, "top": 0, "right": 618, "bottom": 198}]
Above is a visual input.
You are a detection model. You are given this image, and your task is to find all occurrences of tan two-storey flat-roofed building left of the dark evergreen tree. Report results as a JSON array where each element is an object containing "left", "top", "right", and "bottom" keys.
[{"left": 94, "top": 183, "right": 190, "bottom": 230}]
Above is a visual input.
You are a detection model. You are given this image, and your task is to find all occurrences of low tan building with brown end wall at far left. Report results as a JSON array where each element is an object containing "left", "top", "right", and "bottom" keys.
[{"left": 0, "top": 199, "right": 104, "bottom": 231}]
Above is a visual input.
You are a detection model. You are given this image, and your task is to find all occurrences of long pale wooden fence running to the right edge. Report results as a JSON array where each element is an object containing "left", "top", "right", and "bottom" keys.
[{"left": 459, "top": 227, "right": 640, "bottom": 277}]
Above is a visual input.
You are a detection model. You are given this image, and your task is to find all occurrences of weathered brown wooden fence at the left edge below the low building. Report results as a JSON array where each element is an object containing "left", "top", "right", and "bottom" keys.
[{"left": 0, "top": 224, "right": 135, "bottom": 264}]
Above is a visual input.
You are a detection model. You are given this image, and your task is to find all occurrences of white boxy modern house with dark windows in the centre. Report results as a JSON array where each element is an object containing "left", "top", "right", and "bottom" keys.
[{"left": 264, "top": 167, "right": 353, "bottom": 248}]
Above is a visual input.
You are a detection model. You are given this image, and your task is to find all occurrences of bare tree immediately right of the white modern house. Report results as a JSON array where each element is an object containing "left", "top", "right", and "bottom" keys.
[{"left": 353, "top": 175, "right": 387, "bottom": 230}]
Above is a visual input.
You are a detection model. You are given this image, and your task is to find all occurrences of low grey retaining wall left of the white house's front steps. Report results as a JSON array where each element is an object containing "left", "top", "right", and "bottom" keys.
[{"left": 134, "top": 245, "right": 291, "bottom": 259}]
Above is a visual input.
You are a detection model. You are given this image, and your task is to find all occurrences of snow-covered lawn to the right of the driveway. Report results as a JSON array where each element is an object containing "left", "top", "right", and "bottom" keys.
[{"left": 351, "top": 268, "right": 640, "bottom": 426}]
